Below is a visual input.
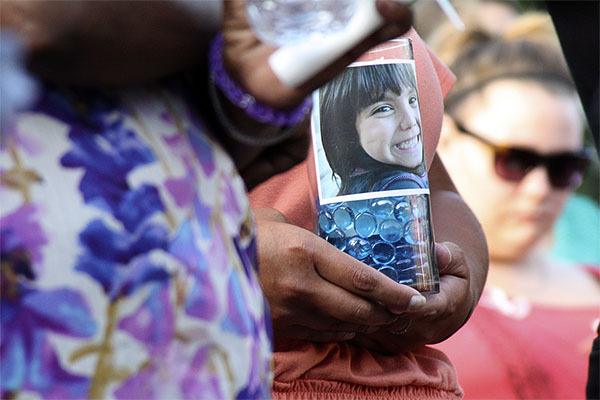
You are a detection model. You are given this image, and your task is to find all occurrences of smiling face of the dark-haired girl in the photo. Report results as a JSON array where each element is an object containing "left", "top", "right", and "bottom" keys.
[{"left": 356, "top": 87, "right": 423, "bottom": 168}]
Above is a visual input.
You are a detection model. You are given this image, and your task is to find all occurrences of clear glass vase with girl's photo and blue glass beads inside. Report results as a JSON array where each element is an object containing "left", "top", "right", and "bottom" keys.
[{"left": 309, "top": 39, "right": 439, "bottom": 293}]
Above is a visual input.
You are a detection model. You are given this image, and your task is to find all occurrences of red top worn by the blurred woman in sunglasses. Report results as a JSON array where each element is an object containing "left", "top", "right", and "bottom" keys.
[{"left": 436, "top": 288, "right": 600, "bottom": 399}]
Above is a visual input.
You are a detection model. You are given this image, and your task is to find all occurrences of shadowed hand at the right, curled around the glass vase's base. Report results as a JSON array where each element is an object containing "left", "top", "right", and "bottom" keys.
[{"left": 346, "top": 242, "right": 476, "bottom": 354}]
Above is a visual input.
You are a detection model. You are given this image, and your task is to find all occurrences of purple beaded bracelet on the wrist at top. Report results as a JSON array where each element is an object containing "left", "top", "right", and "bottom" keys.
[{"left": 208, "top": 34, "right": 312, "bottom": 127}]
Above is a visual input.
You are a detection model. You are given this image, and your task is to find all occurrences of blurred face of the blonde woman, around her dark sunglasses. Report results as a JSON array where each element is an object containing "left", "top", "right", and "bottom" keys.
[{"left": 439, "top": 80, "right": 582, "bottom": 261}]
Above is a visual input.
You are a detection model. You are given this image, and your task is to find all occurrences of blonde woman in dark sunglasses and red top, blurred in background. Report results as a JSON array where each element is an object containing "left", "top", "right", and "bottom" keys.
[{"left": 439, "top": 13, "right": 600, "bottom": 398}]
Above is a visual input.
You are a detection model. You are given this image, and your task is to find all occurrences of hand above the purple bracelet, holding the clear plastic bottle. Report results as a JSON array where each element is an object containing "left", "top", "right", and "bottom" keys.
[{"left": 223, "top": 0, "right": 412, "bottom": 108}]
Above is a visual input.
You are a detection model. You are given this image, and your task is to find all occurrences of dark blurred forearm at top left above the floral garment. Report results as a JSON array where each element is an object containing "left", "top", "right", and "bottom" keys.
[{"left": 0, "top": 0, "right": 221, "bottom": 85}]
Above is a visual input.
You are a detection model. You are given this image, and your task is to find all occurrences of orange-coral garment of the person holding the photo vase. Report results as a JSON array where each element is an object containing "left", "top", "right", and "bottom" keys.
[{"left": 250, "top": 30, "right": 462, "bottom": 399}]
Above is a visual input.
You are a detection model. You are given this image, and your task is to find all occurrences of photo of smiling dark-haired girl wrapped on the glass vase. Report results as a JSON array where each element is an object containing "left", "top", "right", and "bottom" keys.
[{"left": 318, "top": 63, "right": 428, "bottom": 196}]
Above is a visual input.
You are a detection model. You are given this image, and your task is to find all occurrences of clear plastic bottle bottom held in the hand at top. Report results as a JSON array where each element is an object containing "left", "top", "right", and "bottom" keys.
[{"left": 246, "top": 0, "right": 356, "bottom": 47}]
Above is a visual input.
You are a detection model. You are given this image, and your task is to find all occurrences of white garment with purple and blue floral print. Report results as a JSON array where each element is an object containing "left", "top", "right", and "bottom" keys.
[{"left": 0, "top": 83, "right": 272, "bottom": 399}]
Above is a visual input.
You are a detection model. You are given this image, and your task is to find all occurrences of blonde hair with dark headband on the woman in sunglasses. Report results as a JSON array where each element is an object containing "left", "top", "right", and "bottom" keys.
[{"left": 433, "top": 13, "right": 575, "bottom": 114}]
